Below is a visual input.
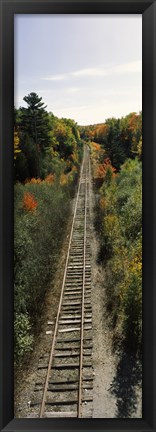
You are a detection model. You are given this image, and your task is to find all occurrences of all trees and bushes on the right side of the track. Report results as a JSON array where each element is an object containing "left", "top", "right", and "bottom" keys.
[{"left": 83, "top": 113, "right": 142, "bottom": 356}]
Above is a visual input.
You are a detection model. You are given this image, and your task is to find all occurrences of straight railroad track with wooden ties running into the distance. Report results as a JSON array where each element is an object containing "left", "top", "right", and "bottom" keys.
[{"left": 30, "top": 146, "right": 93, "bottom": 418}]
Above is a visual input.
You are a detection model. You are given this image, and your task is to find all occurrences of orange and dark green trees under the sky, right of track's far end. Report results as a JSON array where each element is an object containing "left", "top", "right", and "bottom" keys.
[{"left": 80, "top": 112, "right": 142, "bottom": 171}]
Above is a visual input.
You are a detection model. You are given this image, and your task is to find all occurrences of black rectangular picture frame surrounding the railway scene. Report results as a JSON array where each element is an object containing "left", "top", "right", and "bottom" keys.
[{"left": 0, "top": 0, "right": 156, "bottom": 432}]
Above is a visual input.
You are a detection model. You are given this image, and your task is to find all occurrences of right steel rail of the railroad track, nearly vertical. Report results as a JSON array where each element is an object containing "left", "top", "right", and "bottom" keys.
[{"left": 77, "top": 160, "right": 87, "bottom": 418}]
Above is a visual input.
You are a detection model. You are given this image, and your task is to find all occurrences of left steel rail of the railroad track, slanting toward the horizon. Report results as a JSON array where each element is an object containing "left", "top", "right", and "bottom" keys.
[{"left": 39, "top": 149, "right": 85, "bottom": 418}]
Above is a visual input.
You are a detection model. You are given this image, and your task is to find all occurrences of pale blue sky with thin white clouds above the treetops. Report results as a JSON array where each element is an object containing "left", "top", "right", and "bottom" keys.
[{"left": 14, "top": 14, "right": 142, "bottom": 125}]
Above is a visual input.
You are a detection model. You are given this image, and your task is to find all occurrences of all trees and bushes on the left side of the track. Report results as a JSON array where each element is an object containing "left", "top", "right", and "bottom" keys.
[{"left": 14, "top": 93, "right": 83, "bottom": 366}]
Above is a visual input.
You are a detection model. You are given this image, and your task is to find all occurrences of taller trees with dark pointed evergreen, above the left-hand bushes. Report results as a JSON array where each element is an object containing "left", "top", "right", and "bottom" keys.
[{"left": 14, "top": 92, "right": 82, "bottom": 182}]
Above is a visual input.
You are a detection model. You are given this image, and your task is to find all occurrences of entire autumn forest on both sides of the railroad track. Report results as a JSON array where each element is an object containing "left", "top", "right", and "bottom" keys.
[{"left": 14, "top": 93, "right": 142, "bottom": 366}]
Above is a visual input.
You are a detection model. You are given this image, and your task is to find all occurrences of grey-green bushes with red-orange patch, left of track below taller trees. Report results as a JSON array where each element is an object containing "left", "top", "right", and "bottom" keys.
[{"left": 14, "top": 177, "right": 73, "bottom": 362}]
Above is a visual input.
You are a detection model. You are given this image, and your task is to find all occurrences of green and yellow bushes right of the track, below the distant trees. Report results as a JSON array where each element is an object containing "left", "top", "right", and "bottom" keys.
[{"left": 95, "top": 159, "right": 142, "bottom": 352}]
